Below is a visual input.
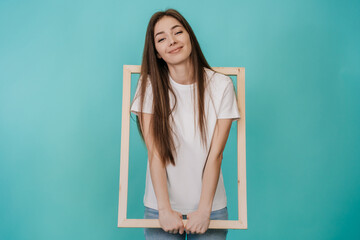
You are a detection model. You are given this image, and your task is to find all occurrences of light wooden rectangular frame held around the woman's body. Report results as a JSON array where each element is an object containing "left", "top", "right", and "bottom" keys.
[{"left": 118, "top": 65, "right": 247, "bottom": 229}]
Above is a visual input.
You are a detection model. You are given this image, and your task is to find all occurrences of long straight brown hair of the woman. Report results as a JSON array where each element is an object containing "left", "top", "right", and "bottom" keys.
[{"left": 136, "top": 9, "right": 211, "bottom": 166}]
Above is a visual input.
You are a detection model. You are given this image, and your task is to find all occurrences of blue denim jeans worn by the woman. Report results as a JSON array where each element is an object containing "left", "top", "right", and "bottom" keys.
[{"left": 144, "top": 207, "right": 228, "bottom": 240}]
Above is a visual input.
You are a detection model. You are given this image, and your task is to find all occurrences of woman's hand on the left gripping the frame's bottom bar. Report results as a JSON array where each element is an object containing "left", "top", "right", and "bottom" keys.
[{"left": 159, "top": 209, "right": 184, "bottom": 234}]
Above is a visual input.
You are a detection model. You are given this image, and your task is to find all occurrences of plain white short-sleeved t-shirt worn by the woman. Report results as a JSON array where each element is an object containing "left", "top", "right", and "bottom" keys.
[{"left": 131, "top": 68, "right": 240, "bottom": 214}]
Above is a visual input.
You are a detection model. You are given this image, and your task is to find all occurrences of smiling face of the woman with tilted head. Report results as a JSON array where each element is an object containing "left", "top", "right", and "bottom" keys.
[{"left": 154, "top": 16, "right": 191, "bottom": 65}]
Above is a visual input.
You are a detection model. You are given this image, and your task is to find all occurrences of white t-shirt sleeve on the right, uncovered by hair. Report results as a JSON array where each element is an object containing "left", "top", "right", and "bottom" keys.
[{"left": 218, "top": 78, "right": 240, "bottom": 120}]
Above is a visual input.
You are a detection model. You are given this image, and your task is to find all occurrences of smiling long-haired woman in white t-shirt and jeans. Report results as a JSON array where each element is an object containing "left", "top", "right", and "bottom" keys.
[{"left": 131, "top": 9, "right": 240, "bottom": 239}]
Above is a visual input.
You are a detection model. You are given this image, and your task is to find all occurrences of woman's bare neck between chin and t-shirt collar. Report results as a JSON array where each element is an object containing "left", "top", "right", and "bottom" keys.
[{"left": 168, "top": 59, "right": 194, "bottom": 84}]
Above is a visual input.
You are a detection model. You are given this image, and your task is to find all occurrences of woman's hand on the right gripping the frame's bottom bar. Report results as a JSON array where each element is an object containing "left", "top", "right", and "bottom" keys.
[{"left": 185, "top": 209, "right": 210, "bottom": 234}]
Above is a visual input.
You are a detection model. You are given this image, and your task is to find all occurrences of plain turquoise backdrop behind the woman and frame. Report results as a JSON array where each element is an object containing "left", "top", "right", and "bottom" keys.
[{"left": 0, "top": 0, "right": 360, "bottom": 240}]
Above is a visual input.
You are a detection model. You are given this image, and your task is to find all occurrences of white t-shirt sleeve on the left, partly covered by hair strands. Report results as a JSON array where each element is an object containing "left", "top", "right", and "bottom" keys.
[{"left": 131, "top": 80, "right": 153, "bottom": 115}]
